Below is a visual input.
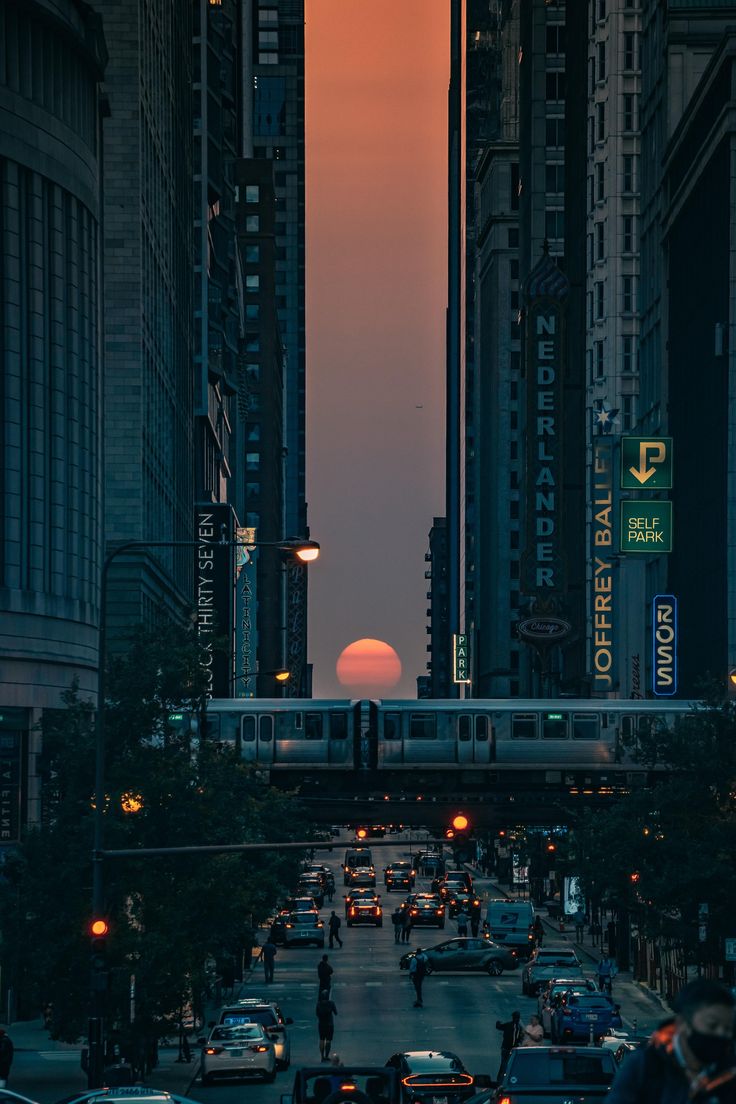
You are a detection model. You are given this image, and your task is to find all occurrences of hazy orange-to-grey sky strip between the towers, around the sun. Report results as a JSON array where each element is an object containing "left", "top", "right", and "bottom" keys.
[{"left": 306, "top": 0, "right": 449, "bottom": 698}]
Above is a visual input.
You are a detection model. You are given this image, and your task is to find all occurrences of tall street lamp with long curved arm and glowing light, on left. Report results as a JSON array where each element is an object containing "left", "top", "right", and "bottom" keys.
[{"left": 87, "top": 527, "right": 320, "bottom": 1089}]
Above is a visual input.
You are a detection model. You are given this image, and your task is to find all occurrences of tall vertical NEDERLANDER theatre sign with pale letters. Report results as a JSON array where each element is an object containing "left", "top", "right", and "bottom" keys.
[{"left": 523, "top": 300, "right": 564, "bottom": 597}]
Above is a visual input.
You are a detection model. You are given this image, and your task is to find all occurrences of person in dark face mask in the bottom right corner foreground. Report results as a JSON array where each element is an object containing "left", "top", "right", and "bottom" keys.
[{"left": 606, "top": 977, "right": 736, "bottom": 1104}]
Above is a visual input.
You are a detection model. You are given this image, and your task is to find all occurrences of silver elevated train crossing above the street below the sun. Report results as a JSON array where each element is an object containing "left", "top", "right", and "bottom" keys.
[{"left": 189, "top": 698, "right": 695, "bottom": 775}]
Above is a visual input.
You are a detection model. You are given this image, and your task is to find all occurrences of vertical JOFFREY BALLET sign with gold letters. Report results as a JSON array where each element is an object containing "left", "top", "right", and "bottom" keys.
[{"left": 589, "top": 437, "right": 614, "bottom": 693}]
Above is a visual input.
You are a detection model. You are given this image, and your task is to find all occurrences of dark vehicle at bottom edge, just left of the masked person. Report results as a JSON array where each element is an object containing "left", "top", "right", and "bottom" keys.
[{"left": 493, "top": 1047, "right": 617, "bottom": 1104}]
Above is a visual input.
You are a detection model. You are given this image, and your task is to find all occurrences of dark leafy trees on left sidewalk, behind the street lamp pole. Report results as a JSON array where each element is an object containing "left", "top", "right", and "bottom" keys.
[{"left": 0, "top": 627, "right": 313, "bottom": 1039}]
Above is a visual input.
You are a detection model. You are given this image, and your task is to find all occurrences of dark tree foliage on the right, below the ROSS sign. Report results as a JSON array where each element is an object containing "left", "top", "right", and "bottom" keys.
[{"left": 562, "top": 696, "right": 736, "bottom": 962}]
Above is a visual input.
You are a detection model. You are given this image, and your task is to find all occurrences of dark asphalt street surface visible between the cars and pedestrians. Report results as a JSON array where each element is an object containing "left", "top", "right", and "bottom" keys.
[{"left": 9, "top": 840, "right": 662, "bottom": 1104}]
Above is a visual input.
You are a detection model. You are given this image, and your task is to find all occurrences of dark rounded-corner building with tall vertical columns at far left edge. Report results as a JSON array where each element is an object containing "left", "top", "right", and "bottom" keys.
[{"left": 0, "top": 0, "right": 106, "bottom": 830}]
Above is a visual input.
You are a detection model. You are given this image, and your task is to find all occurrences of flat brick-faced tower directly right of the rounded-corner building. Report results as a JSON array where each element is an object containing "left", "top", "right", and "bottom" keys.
[{"left": 95, "top": 0, "right": 194, "bottom": 634}]
